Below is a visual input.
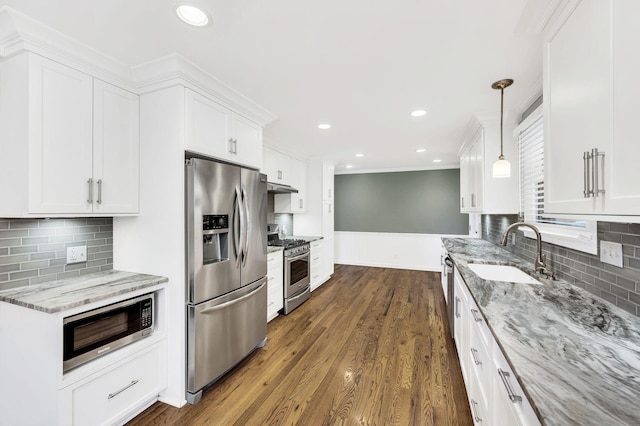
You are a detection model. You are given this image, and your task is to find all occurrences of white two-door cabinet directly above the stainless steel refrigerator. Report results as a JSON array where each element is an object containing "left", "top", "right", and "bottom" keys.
[{"left": 185, "top": 89, "right": 262, "bottom": 168}]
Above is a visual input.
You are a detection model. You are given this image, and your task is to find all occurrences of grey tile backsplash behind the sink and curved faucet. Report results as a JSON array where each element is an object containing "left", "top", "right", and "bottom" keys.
[{"left": 482, "top": 215, "right": 640, "bottom": 316}]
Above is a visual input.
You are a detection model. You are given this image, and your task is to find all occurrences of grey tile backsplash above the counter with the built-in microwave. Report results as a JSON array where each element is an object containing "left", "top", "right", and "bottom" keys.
[{"left": 0, "top": 218, "right": 113, "bottom": 290}]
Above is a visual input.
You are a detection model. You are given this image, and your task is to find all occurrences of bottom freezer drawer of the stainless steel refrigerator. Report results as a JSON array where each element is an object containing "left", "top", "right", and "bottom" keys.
[{"left": 187, "top": 277, "right": 267, "bottom": 400}]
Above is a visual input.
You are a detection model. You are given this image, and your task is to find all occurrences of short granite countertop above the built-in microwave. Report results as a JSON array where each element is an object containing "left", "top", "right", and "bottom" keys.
[{"left": 0, "top": 270, "right": 169, "bottom": 313}]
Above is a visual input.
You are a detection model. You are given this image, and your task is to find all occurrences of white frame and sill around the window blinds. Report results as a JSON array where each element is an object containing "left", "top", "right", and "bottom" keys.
[{"left": 513, "top": 105, "right": 598, "bottom": 254}]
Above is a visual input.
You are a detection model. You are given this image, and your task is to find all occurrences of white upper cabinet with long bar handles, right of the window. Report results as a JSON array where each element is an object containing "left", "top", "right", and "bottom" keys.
[{"left": 544, "top": 0, "right": 640, "bottom": 216}]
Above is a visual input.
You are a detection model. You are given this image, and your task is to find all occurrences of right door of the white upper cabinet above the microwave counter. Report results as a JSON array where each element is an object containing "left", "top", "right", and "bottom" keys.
[{"left": 93, "top": 80, "right": 140, "bottom": 214}]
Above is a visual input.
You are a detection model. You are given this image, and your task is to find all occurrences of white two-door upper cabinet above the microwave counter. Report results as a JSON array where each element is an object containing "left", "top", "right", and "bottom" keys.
[{"left": 0, "top": 53, "right": 139, "bottom": 217}]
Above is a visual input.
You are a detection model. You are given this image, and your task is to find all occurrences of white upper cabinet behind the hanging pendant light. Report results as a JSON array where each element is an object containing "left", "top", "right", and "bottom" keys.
[{"left": 460, "top": 117, "right": 520, "bottom": 214}]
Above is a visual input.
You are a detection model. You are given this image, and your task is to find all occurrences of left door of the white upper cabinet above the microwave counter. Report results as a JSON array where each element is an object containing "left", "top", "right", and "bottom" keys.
[{"left": 29, "top": 55, "right": 93, "bottom": 214}]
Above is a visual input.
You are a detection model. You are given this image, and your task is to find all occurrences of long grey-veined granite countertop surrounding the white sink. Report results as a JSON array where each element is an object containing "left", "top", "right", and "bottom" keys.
[{"left": 442, "top": 238, "right": 640, "bottom": 426}]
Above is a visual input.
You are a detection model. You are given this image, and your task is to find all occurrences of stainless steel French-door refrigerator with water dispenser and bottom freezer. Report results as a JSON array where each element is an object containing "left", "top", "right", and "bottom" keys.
[{"left": 185, "top": 158, "right": 267, "bottom": 404}]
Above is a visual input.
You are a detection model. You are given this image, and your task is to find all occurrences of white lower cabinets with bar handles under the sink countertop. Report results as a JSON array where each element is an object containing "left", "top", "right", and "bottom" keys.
[{"left": 454, "top": 270, "right": 540, "bottom": 426}]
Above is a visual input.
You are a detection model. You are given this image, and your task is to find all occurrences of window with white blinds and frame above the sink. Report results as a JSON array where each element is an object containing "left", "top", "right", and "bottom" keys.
[{"left": 516, "top": 106, "right": 597, "bottom": 254}]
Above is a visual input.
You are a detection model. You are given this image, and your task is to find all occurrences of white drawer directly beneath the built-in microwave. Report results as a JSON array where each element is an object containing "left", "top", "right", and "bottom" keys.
[{"left": 72, "top": 347, "right": 164, "bottom": 425}]
